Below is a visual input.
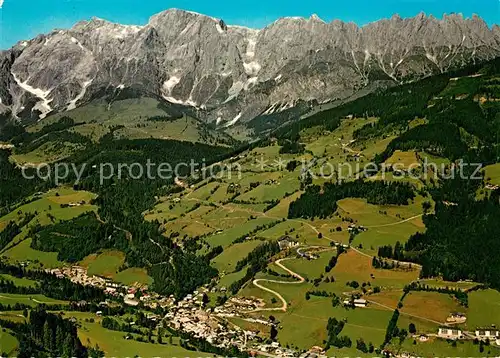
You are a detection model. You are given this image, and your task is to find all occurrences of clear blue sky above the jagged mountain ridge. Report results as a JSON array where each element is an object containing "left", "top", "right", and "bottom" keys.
[{"left": 0, "top": 0, "right": 500, "bottom": 49}]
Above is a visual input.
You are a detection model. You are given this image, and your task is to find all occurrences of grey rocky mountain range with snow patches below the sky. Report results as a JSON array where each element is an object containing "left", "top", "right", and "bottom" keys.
[{"left": 0, "top": 9, "right": 500, "bottom": 126}]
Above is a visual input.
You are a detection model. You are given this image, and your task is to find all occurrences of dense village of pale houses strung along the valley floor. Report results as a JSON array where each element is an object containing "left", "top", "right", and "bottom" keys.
[{"left": 46, "top": 266, "right": 336, "bottom": 358}]
